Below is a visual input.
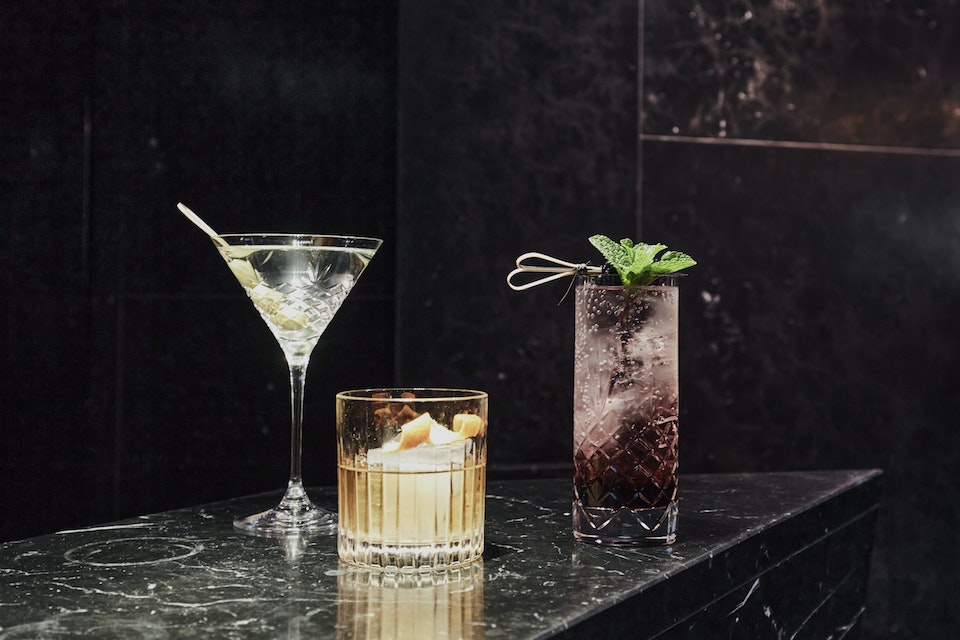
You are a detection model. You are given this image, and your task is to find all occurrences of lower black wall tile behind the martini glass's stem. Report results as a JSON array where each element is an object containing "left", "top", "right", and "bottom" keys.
[{"left": 104, "top": 288, "right": 392, "bottom": 515}]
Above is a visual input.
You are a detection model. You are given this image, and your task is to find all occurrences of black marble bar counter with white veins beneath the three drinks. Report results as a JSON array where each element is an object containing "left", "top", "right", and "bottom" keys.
[{"left": 0, "top": 471, "right": 879, "bottom": 640}]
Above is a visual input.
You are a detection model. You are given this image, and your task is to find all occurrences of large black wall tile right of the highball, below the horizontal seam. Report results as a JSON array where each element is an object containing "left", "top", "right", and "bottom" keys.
[{"left": 644, "top": 143, "right": 960, "bottom": 633}]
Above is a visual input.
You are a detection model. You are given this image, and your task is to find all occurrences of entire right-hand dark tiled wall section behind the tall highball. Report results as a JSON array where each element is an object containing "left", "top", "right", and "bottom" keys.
[{"left": 398, "top": 0, "right": 960, "bottom": 638}]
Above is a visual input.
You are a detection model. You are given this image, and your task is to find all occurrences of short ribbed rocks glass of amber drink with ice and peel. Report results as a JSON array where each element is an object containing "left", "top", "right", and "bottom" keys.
[{"left": 337, "top": 389, "right": 487, "bottom": 569}]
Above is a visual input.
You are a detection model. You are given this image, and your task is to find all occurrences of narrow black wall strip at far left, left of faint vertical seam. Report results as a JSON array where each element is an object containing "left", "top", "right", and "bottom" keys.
[{"left": 0, "top": 3, "right": 96, "bottom": 539}]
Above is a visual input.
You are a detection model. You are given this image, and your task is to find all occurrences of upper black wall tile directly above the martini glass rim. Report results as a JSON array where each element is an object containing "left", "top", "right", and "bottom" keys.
[{"left": 94, "top": 2, "right": 396, "bottom": 293}]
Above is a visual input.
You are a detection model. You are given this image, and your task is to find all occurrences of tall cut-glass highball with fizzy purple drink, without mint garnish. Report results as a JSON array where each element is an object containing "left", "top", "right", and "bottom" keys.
[{"left": 573, "top": 274, "right": 679, "bottom": 545}]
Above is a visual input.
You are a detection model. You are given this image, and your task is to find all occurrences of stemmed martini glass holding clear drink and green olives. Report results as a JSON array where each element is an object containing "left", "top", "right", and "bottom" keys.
[{"left": 212, "top": 234, "right": 381, "bottom": 536}]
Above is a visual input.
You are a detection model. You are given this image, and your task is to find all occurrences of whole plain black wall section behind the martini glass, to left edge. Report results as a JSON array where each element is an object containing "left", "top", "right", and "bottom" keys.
[{"left": 0, "top": 1, "right": 397, "bottom": 539}]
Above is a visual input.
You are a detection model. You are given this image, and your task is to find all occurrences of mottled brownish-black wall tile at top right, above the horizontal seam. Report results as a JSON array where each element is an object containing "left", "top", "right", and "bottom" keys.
[{"left": 643, "top": 0, "right": 960, "bottom": 148}]
